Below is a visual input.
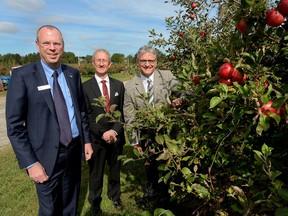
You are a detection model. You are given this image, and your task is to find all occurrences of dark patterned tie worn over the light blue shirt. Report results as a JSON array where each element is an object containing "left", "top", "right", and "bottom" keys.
[{"left": 53, "top": 71, "right": 72, "bottom": 146}]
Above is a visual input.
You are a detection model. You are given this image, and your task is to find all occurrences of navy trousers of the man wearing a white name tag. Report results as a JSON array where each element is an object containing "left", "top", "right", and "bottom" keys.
[{"left": 35, "top": 137, "right": 82, "bottom": 216}]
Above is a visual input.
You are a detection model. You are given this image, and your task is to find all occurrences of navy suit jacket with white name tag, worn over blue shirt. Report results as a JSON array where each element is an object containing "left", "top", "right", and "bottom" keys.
[{"left": 6, "top": 61, "right": 90, "bottom": 176}]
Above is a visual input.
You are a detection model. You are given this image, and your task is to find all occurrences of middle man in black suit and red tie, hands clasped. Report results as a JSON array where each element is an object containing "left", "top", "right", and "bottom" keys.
[{"left": 83, "top": 49, "right": 125, "bottom": 215}]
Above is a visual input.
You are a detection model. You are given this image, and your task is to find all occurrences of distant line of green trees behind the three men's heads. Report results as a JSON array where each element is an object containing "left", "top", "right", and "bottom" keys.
[{"left": 0, "top": 48, "right": 166, "bottom": 76}]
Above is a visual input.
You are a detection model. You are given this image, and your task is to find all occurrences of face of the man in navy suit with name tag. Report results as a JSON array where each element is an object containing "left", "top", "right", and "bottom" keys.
[{"left": 36, "top": 27, "right": 64, "bottom": 69}]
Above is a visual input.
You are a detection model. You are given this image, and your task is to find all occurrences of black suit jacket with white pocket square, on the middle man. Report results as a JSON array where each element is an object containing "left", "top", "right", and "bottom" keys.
[{"left": 83, "top": 77, "right": 124, "bottom": 144}]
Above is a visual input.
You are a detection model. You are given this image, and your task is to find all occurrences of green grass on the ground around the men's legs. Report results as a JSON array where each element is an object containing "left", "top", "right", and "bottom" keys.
[{"left": 0, "top": 145, "right": 160, "bottom": 216}]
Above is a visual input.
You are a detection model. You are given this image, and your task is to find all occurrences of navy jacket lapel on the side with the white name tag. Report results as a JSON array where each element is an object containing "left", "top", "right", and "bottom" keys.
[{"left": 33, "top": 61, "right": 57, "bottom": 119}]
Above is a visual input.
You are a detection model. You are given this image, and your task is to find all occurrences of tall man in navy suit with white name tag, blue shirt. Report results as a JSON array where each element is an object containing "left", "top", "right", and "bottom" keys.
[{"left": 6, "top": 25, "right": 93, "bottom": 216}]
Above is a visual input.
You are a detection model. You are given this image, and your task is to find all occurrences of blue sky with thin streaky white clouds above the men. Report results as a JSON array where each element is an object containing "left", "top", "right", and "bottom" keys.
[{"left": 0, "top": 0, "right": 177, "bottom": 56}]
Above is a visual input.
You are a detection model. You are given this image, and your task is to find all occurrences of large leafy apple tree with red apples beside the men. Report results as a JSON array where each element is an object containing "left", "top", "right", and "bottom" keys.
[{"left": 121, "top": 0, "right": 288, "bottom": 215}]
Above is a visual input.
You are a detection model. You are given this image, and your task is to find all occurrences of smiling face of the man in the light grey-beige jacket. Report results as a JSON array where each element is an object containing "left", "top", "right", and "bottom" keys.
[{"left": 137, "top": 53, "right": 157, "bottom": 77}]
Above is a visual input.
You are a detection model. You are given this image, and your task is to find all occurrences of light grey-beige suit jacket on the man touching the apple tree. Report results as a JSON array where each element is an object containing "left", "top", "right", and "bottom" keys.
[{"left": 123, "top": 69, "right": 179, "bottom": 145}]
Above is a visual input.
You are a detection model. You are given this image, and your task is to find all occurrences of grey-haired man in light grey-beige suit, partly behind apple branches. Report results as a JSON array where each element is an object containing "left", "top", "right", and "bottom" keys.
[{"left": 123, "top": 46, "right": 181, "bottom": 204}]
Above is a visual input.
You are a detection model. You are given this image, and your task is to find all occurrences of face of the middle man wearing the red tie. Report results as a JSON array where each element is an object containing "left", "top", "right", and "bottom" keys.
[{"left": 92, "top": 51, "right": 112, "bottom": 78}]
